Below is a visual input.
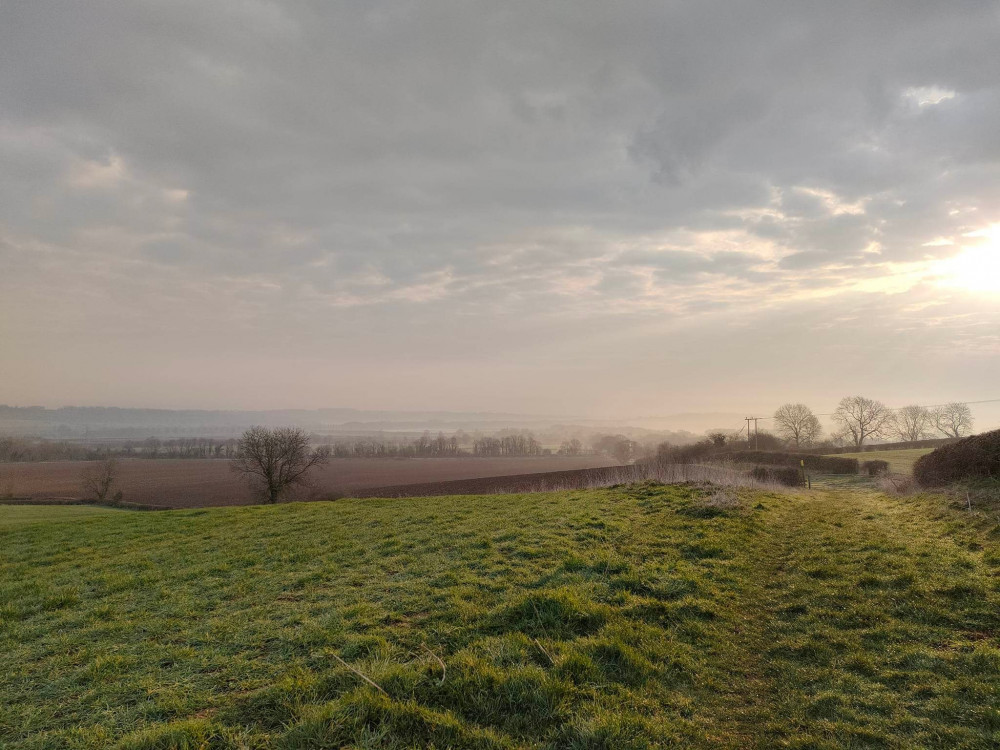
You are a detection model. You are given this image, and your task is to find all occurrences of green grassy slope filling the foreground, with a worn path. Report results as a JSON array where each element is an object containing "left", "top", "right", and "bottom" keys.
[{"left": 0, "top": 487, "right": 1000, "bottom": 749}]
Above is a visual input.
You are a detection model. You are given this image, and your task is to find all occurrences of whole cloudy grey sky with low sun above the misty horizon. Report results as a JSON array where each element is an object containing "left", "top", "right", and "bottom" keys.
[{"left": 0, "top": 0, "right": 1000, "bottom": 427}]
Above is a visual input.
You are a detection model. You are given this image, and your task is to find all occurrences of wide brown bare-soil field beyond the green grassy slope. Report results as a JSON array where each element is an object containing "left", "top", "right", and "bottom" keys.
[{"left": 0, "top": 456, "right": 615, "bottom": 508}]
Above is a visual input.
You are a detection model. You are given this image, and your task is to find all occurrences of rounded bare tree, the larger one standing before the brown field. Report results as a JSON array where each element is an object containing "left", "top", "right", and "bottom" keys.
[{"left": 230, "top": 426, "right": 330, "bottom": 503}]
